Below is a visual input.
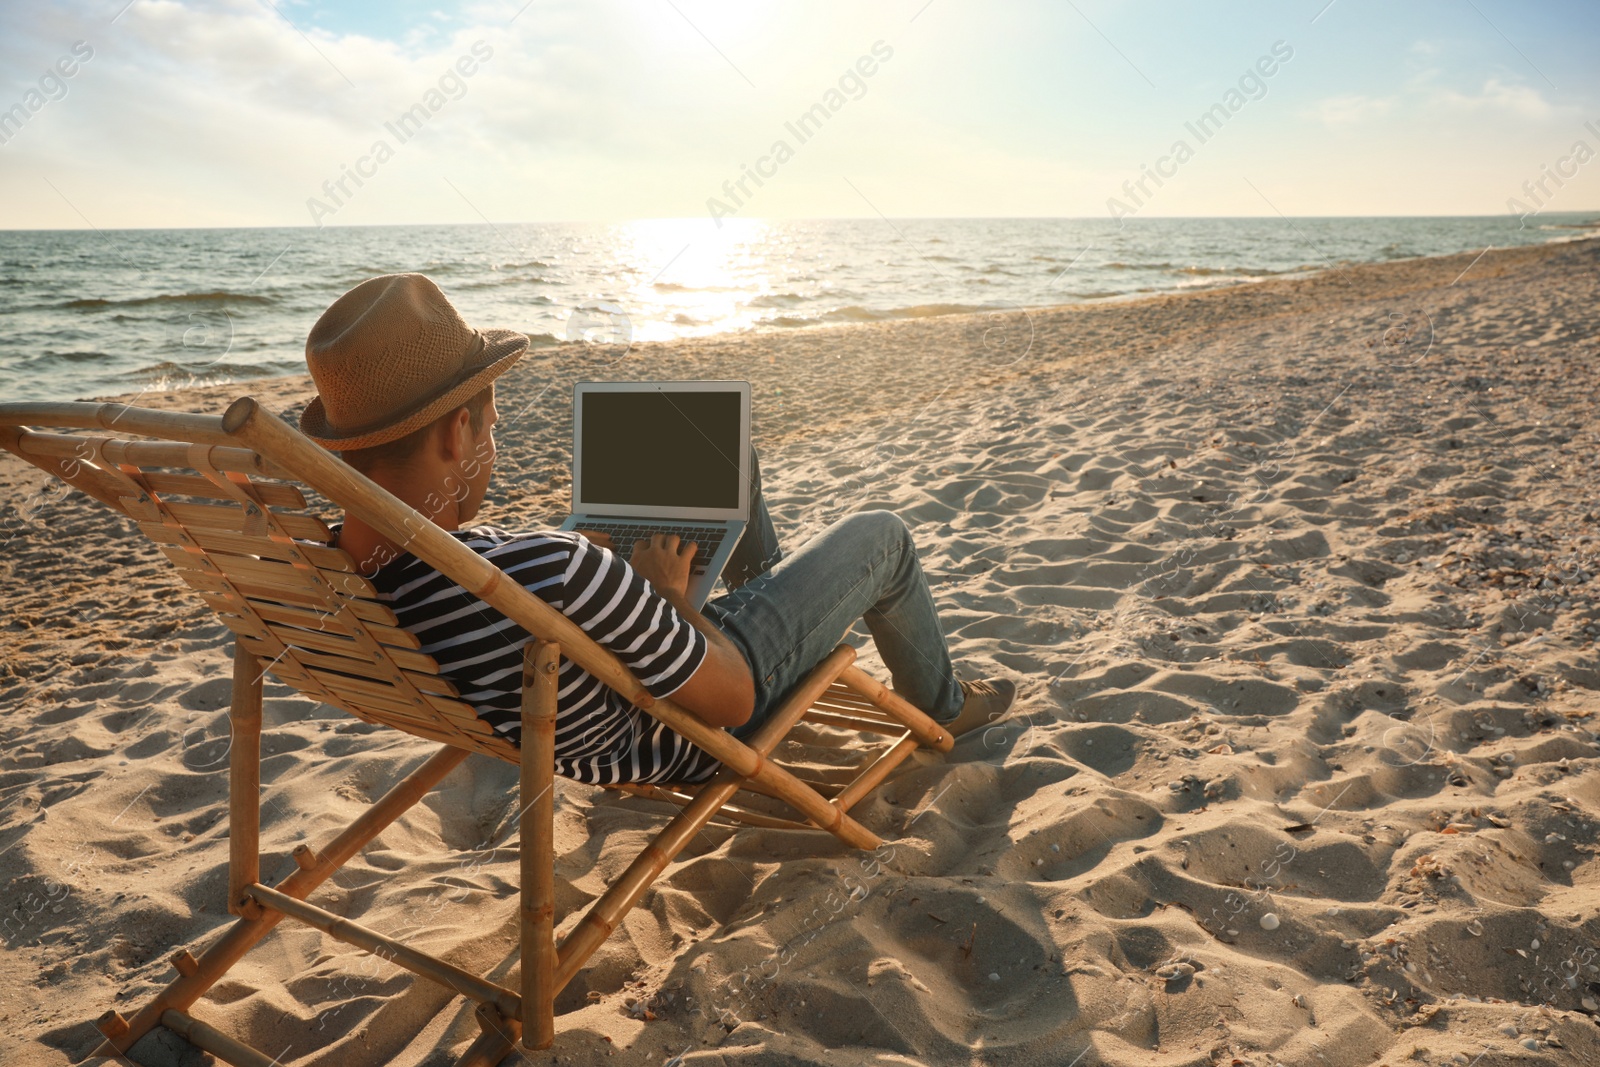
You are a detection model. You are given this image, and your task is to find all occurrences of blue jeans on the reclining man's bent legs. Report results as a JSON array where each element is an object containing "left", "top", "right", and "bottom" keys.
[{"left": 704, "top": 450, "right": 963, "bottom": 737}]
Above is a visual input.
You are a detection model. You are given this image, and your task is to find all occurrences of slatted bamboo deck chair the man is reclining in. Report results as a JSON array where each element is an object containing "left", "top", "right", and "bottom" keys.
[{"left": 0, "top": 397, "right": 954, "bottom": 1067}]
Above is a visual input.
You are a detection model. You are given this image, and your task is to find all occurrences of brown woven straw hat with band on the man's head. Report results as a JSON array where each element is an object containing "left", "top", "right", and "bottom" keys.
[{"left": 301, "top": 274, "right": 528, "bottom": 451}]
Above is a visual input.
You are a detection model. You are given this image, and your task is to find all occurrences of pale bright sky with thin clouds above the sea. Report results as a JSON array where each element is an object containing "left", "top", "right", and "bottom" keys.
[{"left": 0, "top": 0, "right": 1600, "bottom": 229}]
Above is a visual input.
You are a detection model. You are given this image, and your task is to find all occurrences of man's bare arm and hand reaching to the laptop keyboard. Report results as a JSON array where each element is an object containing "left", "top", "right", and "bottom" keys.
[{"left": 614, "top": 534, "right": 755, "bottom": 726}]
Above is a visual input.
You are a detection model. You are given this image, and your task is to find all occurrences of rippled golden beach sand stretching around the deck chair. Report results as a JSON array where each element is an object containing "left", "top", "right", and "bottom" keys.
[{"left": 0, "top": 242, "right": 1600, "bottom": 1067}]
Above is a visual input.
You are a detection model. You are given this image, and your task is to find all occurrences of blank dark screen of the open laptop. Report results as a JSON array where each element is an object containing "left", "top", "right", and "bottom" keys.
[{"left": 578, "top": 389, "right": 739, "bottom": 507}]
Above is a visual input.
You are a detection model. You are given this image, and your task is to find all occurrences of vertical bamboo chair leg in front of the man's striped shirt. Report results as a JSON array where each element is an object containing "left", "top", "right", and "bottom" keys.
[{"left": 518, "top": 641, "right": 562, "bottom": 1049}]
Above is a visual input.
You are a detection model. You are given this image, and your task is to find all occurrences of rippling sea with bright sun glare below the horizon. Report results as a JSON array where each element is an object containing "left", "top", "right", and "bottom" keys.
[{"left": 0, "top": 213, "right": 1600, "bottom": 400}]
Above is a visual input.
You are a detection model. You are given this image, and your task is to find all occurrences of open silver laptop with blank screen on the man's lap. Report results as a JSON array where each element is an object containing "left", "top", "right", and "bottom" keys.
[{"left": 562, "top": 382, "right": 750, "bottom": 611}]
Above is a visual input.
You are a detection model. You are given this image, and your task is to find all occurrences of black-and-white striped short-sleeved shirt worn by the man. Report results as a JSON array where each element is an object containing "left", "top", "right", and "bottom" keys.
[{"left": 371, "top": 526, "right": 718, "bottom": 785}]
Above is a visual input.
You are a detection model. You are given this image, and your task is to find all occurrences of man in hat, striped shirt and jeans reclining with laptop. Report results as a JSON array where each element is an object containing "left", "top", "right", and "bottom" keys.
[{"left": 301, "top": 274, "right": 1014, "bottom": 784}]
